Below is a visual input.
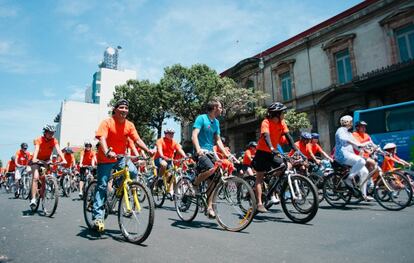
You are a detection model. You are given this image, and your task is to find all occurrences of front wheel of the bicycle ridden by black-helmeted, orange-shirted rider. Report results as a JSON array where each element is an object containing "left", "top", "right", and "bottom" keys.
[{"left": 280, "top": 174, "right": 319, "bottom": 224}]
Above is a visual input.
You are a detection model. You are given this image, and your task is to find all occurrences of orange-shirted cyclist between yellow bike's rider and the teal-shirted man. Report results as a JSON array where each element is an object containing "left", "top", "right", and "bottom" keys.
[{"left": 154, "top": 128, "right": 185, "bottom": 199}]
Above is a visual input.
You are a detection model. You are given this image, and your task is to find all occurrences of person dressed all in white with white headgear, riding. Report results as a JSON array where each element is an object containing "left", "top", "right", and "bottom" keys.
[{"left": 335, "top": 115, "right": 373, "bottom": 201}]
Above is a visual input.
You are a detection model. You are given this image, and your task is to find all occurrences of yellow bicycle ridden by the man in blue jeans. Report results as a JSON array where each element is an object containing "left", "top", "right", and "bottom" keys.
[{"left": 83, "top": 155, "right": 155, "bottom": 244}]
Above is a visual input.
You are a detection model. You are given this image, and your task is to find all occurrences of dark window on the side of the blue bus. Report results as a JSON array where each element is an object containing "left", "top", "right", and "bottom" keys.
[{"left": 385, "top": 106, "right": 414, "bottom": 132}]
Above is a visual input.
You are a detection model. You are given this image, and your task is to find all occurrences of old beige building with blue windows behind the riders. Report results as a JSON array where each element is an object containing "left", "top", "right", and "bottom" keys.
[{"left": 221, "top": 0, "right": 414, "bottom": 151}]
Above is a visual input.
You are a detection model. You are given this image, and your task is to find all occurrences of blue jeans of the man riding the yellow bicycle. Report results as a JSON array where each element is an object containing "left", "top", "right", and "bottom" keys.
[{"left": 92, "top": 158, "right": 138, "bottom": 220}]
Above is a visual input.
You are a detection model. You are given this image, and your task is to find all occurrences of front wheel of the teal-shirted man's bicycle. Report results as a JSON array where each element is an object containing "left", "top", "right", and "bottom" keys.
[{"left": 213, "top": 177, "right": 257, "bottom": 232}]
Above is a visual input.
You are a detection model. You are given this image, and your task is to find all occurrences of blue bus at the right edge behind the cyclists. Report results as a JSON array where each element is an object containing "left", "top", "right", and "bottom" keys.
[{"left": 354, "top": 101, "right": 414, "bottom": 161}]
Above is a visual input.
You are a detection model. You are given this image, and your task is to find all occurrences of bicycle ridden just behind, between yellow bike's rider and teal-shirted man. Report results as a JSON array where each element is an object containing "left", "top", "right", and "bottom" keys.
[{"left": 149, "top": 158, "right": 187, "bottom": 208}]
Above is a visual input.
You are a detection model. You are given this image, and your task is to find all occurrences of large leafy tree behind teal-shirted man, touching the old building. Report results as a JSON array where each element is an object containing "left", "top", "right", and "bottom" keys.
[{"left": 160, "top": 64, "right": 266, "bottom": 123}]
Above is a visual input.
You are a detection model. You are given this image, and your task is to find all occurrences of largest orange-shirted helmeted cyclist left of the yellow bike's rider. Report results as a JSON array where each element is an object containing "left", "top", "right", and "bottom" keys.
[{"left": 30, "top": 124, "right": 66, "bottom": 208}]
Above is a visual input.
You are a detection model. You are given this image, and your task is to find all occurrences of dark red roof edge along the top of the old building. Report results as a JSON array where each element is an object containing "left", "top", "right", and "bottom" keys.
[{"left": 220, "top": 0, "right": 380, "bottom": 77}]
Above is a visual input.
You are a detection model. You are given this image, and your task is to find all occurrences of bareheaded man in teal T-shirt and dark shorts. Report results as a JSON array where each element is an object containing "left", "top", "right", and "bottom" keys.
[{"left": 191, "top": 100, "right": 230, "bottom": 218}]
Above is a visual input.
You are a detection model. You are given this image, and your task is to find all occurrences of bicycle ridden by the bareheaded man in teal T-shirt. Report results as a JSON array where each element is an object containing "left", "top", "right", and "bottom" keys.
[{"left": 174, "top": 154, "right": 257, "bottom": 232}]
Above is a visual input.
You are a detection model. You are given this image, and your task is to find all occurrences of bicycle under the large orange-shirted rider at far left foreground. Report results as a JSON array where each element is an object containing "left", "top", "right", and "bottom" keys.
[{"left": 32, "top": 160, "right": 59, "bottom": 217}]
